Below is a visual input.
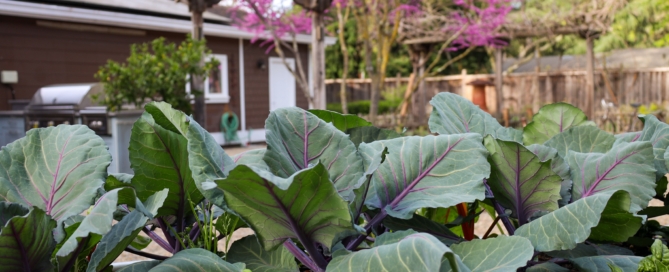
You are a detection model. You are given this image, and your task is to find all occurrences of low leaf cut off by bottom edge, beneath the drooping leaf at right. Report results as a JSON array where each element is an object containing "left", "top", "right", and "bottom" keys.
[{"left": 570, "top": 255, "right": 642, "bottom": 272}]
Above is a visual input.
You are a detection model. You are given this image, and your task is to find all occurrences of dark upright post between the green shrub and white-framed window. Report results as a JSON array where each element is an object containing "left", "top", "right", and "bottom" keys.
[{"left": 190, "top": 0, "right": 206, "bottom": 127}]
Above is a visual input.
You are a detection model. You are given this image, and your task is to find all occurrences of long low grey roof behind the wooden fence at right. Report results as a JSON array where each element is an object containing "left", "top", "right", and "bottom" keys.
[{"left": 502, "top": 47, "right": 669, "bottom": 73}]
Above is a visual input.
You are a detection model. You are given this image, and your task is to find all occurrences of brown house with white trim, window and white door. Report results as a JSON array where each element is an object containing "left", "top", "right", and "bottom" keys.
[{"left": 0, "top": 0, "right": 334, "bottom": 144}]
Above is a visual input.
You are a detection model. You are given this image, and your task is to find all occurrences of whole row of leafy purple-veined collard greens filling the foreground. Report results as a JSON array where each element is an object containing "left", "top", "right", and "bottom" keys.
[{"left": 0, "top": 93, "right": 669, "bottom": 272}]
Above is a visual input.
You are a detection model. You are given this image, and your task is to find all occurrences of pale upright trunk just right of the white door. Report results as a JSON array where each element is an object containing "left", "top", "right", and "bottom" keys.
[{"left": 311, "top": 12, "right": 325, "bottom": 109}]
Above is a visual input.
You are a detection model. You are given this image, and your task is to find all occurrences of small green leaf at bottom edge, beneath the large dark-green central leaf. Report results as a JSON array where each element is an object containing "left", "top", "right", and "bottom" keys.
[{"left": 226, "top": 235, "right": 298, "bottom": 272}]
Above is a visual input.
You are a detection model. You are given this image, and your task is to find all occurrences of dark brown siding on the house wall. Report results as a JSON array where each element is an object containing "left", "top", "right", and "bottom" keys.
[{"left": 0, "top": 15, "right": 309, "bottom": 132}]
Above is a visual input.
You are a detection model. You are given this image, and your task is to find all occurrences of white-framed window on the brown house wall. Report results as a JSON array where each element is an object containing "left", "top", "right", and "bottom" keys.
[{"left": 186, "top": 54, "right": 230, "bottom": 104}]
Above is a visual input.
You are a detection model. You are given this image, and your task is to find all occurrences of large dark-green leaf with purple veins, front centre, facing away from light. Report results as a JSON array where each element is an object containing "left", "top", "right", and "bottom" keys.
[{"left": 205, "top": 163, "right": 353, "bottom": 251}]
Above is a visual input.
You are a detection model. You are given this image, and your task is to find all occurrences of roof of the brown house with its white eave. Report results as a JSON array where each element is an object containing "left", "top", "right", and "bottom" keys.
[{"left": 0, "top": 0, "right": 336, "bottom": 45}]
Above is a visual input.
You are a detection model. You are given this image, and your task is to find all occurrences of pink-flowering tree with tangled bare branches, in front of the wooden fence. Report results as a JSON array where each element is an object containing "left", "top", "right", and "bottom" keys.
[{"left": 400, "top": 0, "right": 511, "bottom": 122}]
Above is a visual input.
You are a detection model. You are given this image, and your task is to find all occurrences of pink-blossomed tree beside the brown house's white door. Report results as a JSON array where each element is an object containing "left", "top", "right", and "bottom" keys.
[{"left": 233, "top": 0, "right": 331, "bottom": 108}]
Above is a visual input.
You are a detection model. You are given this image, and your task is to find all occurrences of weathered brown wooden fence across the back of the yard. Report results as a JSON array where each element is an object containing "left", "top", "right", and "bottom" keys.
[{"left": 326, "top": 67, "right": 669, "bottom": 126}]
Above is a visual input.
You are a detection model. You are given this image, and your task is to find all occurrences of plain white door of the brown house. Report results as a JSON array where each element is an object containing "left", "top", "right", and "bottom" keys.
[{"left": 268, "top": 58, "right": 296, "bottom": 111}]
